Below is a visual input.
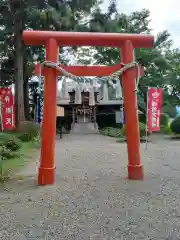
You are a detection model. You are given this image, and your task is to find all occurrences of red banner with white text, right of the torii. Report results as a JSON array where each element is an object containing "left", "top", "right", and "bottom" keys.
[{"left": 148, "top": 88, "right": 163, "bottom": 132}]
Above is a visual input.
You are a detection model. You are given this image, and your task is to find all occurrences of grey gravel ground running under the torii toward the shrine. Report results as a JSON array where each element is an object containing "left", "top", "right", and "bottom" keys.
[{"left": 0, "top": 134, "right": 180, "bottom": 240}]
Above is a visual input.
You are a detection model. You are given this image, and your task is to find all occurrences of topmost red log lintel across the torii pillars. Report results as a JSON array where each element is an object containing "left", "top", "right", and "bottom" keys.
[{"left": 23, "top": 30, "right": 154, "bottom": 48}]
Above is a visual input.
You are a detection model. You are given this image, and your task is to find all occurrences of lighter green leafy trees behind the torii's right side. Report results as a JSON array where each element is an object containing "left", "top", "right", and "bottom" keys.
[{"left": 75, "top": 6, "right": 179, "bottom": 114}]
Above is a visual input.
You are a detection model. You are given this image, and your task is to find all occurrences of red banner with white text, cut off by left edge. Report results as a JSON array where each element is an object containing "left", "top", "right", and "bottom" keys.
[{"left": 0, "top": 88, "right": 14, "bottom": 131}]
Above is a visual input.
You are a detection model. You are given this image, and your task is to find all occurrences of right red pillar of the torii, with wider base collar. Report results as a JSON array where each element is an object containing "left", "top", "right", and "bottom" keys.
[{"left": 121, "top": 40, "right": 144, "bottom": 180}]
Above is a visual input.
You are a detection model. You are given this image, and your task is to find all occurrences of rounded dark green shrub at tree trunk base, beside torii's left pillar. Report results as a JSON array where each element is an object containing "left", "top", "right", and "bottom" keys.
[{"left": 16, "top": 122, "right": 40, "bottom": 142}]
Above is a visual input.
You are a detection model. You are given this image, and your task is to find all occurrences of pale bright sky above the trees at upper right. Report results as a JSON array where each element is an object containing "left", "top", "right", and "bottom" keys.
[{"left": 102, "top": 0, "right": 180, "bottom": 47}]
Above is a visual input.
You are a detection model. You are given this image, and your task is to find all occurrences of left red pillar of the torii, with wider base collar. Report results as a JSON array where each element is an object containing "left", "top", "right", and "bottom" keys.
[{"left": 38, "top": 38, "right": 59, "bottom": 185}]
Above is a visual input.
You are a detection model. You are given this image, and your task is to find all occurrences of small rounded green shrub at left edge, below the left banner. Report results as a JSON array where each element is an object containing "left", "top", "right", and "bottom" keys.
[{"left": 1, "top": 136, "right": 21, "bottom": 151}]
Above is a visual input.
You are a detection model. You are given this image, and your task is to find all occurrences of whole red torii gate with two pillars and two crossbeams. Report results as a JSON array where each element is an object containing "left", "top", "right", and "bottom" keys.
[{"left": 23, "top": 31, "right": 154, "bottom": 185}]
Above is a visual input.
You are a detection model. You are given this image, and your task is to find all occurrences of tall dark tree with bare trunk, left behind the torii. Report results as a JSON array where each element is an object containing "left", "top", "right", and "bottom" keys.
[{"left": 0, "top": 0, "right": 101, "bottom": 123}]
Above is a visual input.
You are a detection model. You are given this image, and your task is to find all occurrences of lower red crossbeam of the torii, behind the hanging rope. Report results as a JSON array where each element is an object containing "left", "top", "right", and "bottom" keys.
[{"left": 34, "top": 63, "right": 144, "bottom": 78}]
